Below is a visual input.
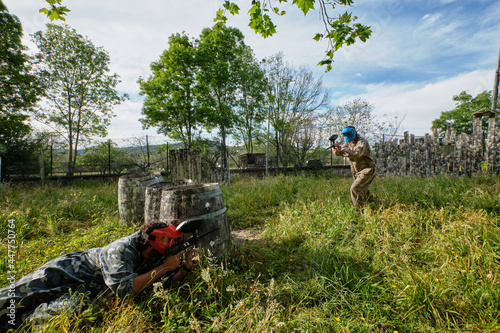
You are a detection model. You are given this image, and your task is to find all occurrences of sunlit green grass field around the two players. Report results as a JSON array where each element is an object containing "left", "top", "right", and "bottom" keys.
[{"left": 0, "top": 175, "right": 500, "bottom": 333}]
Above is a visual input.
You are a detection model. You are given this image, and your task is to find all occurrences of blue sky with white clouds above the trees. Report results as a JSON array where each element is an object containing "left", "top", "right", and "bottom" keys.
[{"left": 3, "top": 0, "right": 500, "bottom": 140}]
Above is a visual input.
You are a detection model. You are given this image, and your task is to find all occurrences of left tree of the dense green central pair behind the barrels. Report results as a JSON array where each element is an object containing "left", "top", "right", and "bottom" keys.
[{"left": 139, "top": 34, "right": 204, "bottom": 148}]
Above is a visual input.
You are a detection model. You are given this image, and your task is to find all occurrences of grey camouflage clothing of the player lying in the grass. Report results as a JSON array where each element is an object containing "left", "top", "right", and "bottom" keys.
[{"left": 0, "top": 233, "right": 175, "bottom": 331}]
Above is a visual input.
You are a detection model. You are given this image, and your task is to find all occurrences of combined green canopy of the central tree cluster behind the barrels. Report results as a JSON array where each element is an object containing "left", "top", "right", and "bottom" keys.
[{"left": 139, "top": 26, "right": 265, "bottom": 157}]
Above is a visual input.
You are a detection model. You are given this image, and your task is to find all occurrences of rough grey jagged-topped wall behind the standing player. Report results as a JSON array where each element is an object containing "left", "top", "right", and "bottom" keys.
[{"left": 373, "top": 113, "right": 500, "bottom": 177}]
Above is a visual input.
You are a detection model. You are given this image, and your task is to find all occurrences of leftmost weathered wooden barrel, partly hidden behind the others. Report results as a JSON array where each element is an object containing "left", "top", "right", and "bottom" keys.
[{"left": 118, "top": 172, "right": 163, "bottom": 225}]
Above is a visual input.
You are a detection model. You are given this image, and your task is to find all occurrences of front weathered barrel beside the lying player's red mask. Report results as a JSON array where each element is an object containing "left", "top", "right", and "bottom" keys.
[{"left": 160, "top": 183, "right": 231, "bottom": 257}]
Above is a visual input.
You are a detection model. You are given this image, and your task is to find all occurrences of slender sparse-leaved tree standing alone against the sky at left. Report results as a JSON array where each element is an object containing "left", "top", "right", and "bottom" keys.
[{"left": 33, "top": 24, "right": 126, "bottom": 175}]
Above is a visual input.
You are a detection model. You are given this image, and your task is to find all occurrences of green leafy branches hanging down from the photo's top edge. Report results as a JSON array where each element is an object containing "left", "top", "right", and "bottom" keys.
[{"left": 40, "top": 0, "right": 371, "bottom": 71}]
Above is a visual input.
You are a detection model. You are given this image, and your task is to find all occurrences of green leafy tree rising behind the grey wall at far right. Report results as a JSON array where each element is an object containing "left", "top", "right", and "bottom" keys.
[{"left": 432, "top": 91, "right": 499, "bottom": 136}]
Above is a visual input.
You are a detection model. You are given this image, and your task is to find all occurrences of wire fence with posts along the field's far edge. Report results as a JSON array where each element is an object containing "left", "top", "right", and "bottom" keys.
[{"left": 1, "top": 131, "right": 352, "bottom": 181}]
